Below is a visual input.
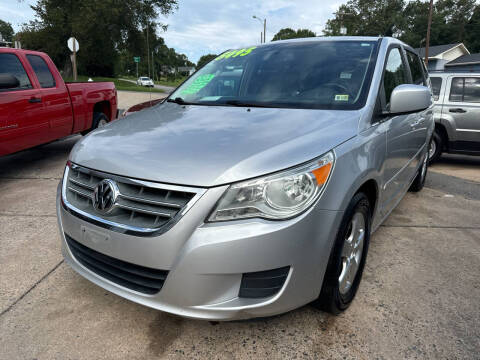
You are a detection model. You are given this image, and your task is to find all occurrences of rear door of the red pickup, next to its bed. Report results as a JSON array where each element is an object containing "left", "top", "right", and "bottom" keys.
[{"left": 26, "top": 54, "right": 73, "bottom": 140}]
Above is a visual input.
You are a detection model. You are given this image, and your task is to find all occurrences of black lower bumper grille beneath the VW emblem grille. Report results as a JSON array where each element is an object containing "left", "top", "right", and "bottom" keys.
[{"left": 65, "top": 234, "right": 168, "bottom": 295}]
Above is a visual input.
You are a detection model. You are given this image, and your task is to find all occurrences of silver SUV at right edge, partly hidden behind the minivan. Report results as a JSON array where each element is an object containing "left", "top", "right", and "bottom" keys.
[{"left": 429, "top": 72, "right": 480, "bottom": 161}]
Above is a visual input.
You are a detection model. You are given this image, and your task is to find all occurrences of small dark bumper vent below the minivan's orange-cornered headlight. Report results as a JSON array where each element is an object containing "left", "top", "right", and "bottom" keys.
[{"left": 238, "top": 266, "right": 290, "bottom": 299}]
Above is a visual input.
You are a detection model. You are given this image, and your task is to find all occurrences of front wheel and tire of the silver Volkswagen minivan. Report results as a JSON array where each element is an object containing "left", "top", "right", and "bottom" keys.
[{"left": 313, "top": 192, "right": 371, "bottom": 315}]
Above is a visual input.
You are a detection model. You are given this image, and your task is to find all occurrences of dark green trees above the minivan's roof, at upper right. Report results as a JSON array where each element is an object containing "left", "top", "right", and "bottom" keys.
[{"left": 324, "top": 0, "right": 480, "bottom": 52}]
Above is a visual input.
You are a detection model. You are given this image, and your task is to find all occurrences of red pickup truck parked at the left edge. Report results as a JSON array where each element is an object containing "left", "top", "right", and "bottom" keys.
[{"left": 0, "top": 48, "right": 118, "bottom": 156}]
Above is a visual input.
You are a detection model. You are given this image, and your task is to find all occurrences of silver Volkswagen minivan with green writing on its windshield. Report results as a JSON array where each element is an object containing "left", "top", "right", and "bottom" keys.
[{"left": 57, "top": 37, "right": 434, "bottom": 320}]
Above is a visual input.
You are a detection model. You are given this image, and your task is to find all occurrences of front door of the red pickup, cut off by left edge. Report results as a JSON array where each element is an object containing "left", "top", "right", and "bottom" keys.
[{"left": 0, "top": 51, "right": 48, "bottom": 155}]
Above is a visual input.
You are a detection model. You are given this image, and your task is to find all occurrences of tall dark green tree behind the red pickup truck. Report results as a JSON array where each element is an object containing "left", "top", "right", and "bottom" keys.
[{"left": 18, "top": 0, "right": 182, "bottom": 76}]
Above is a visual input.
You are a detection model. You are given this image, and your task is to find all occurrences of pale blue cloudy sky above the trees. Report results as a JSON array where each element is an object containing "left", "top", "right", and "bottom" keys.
[{"left": 0, "top": 0, "right": 346, "bottom": 63}]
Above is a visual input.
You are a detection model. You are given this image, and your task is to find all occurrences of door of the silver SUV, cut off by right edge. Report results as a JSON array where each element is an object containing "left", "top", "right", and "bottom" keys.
[{"left": 442, "top": 74, "right": 480, "bottom": 152}]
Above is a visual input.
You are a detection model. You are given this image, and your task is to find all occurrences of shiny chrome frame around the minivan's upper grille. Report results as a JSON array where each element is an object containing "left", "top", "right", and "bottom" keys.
[{"left": 61, "top": 163, "right": 207, "bottom": 236}]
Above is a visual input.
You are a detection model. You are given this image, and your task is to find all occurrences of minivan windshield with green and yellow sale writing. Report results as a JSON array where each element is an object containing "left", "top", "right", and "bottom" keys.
[{"left": 170, "top": 41, "right": 377, "bottom": 110}]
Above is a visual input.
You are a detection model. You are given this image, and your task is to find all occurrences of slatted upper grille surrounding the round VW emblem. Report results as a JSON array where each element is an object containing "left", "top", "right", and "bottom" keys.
[{"left": 65, "top": 164, "right": 198, "bottom": 231}]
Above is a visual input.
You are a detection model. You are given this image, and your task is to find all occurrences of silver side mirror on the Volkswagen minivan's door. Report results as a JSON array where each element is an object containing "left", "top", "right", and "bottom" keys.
[{"left": 390, "top": 84, "right": 432, "bottom": 114}]
